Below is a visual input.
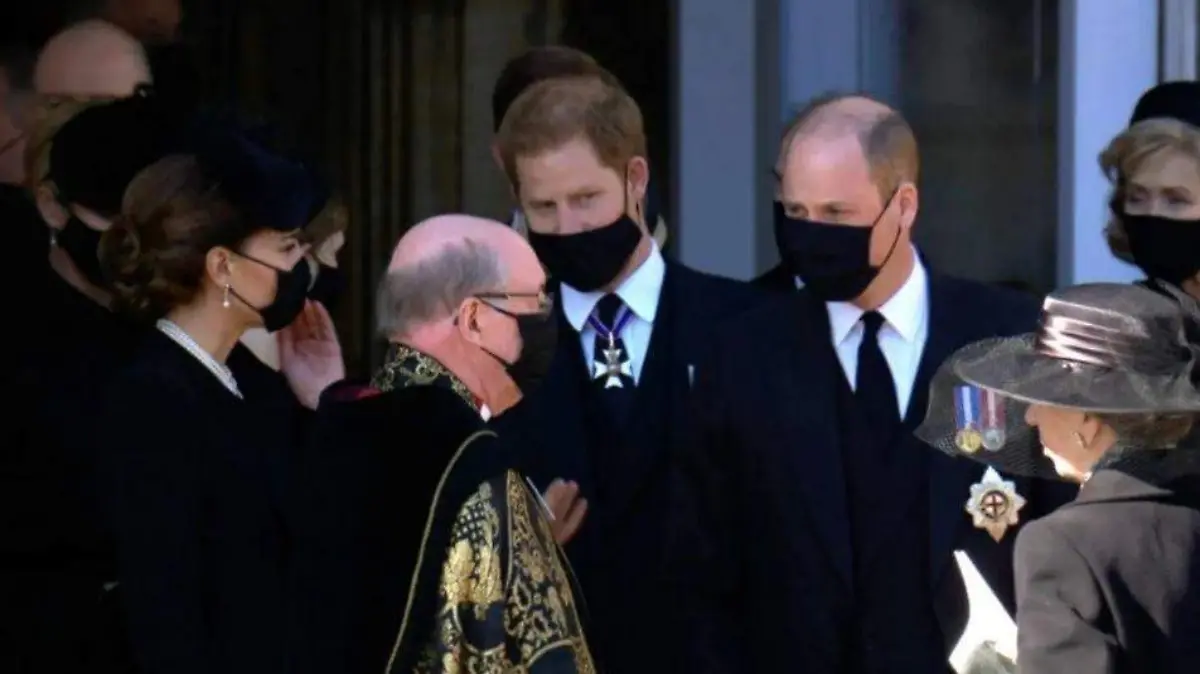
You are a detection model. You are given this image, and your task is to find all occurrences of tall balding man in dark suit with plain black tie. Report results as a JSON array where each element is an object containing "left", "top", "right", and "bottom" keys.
[{"left": 672, "top": 96, "right": 1070, "bottom": 674}]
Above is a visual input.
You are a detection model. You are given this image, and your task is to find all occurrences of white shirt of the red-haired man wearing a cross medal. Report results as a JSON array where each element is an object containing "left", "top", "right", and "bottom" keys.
[{"left": 559, "top": 243, "right": 667, "bottom": 383}]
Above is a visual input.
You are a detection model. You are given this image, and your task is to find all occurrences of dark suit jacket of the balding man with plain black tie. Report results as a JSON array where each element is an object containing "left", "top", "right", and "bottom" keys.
[{"left": 672, "top": 273, "right": 1069, "bottom": 673}]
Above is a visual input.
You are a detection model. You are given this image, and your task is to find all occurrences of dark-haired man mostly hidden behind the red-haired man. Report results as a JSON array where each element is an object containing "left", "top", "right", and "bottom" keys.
[{"left": 492, "top": 44, "right": 667, "bottom": 248}]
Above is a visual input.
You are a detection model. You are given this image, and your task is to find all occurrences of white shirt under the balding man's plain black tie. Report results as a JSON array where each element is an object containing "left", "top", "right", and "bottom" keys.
[{"left": 826, "top": 247, "right": 929, "bottom": 419}]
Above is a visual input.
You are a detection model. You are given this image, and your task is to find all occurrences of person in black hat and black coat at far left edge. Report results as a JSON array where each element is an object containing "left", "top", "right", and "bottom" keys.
[{"left": 0, "top": 90, "right": 184, "bottom": 673}]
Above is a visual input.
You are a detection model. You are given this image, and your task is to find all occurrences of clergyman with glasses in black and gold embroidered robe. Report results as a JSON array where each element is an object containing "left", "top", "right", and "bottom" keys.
[{"left": 293, "top": 216, "right": 594, "bottom": 674}]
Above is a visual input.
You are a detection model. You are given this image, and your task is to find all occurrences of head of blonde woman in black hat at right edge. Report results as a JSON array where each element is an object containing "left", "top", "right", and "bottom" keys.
[{"left": 1100, "top": 82, "right": 1200, "bottom": 299}]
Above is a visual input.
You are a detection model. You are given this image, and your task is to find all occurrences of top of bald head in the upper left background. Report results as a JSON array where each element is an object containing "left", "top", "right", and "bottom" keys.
[{"left": 34, "top": 19, "right": 151, "bottom": 98}]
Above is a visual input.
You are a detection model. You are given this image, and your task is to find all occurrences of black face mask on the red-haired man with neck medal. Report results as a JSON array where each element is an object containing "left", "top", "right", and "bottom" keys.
[{"left": 529, "top": 213, "right": 642, "bottom": 293}]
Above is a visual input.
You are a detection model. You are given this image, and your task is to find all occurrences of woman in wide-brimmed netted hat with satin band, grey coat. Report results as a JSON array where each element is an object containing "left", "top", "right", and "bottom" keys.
[{"left": 917, "top": 283, "right": 1200, "bottom": 674}]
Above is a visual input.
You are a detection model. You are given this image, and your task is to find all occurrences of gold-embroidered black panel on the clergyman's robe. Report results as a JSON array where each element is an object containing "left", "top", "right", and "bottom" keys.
[{"left": 416, "top": 471, "right": 595, "bottom": 674}]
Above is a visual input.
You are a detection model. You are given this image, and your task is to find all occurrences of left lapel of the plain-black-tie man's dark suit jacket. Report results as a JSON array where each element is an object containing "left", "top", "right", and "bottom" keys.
[{"left": 782, "top": 291, "right": 853, "bottom": 584}]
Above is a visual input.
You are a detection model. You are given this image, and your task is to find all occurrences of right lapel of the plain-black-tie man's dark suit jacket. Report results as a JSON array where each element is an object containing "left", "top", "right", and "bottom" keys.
[{"left": 921, "top": 273, "right": 983, "bottom": 588}]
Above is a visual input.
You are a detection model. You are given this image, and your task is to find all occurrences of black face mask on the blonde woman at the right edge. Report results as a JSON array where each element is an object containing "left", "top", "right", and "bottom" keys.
[{"left": 1116, "top": 211, "right": 1200, "bottom": 285}]
